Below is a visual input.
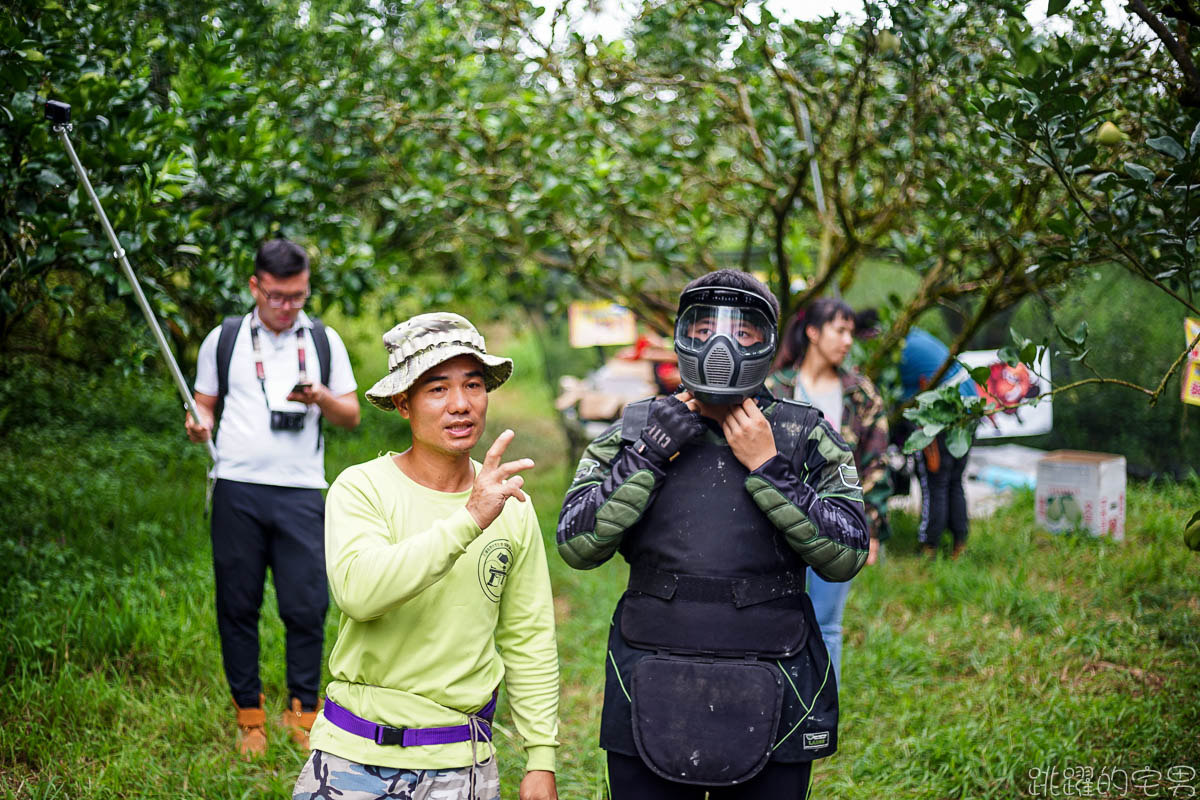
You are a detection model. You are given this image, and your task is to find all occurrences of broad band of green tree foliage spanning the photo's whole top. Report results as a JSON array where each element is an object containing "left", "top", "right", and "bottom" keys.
[{"left": 7, "top": 0, "right": 1200, "bottom": 450}]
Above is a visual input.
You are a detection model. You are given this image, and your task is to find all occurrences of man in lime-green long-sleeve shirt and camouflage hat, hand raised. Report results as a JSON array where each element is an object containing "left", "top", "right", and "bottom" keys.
[{"left": 294, "top": 313, "right": 558, "bottom": 800}]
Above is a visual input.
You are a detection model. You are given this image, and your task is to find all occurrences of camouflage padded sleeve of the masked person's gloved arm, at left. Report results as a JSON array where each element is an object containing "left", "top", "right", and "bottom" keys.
[{"left": 558, "top": 421, "right": 662, "bottom": 570}]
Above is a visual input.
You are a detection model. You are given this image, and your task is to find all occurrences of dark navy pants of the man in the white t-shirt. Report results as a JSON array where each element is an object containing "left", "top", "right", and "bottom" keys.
[{"left": 212, "top": 481, "right": 329, "bottom": 709}]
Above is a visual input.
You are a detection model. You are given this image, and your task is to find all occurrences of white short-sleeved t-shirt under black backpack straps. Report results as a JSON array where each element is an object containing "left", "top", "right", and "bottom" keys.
[{"left": 194, "top": 311, "right": 358, "bottom": 489}]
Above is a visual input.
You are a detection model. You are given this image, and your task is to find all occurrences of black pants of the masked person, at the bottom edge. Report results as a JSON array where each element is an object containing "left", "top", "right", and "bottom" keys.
[{"left": 607, "top": 751, "right": 812, "bottom": 800}]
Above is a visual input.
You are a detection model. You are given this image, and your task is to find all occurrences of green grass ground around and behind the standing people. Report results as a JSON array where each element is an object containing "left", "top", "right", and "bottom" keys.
[{"left": 0, "top": 321, "right": 1200, "bottom": 799}]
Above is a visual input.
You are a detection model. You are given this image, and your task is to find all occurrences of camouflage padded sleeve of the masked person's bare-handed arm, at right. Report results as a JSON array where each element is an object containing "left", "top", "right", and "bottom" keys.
[{"left": 746, "top": 420, "right": 869, "bottom": 582}]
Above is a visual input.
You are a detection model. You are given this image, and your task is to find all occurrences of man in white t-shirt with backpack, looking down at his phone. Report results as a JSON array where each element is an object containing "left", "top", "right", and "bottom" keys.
[{"left": 186, "top": 239, "right": 359, "bottom": 757}]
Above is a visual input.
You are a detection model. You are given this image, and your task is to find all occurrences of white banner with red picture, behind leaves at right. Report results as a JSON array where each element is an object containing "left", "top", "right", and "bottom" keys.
[{"left": 959, "top": 350, "right": 1054, "bottom": 439}]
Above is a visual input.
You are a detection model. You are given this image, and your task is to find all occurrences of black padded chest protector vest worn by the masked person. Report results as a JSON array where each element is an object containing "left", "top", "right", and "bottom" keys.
[{"left": 600, "top": 401, "right": 838, "bottom": 787}]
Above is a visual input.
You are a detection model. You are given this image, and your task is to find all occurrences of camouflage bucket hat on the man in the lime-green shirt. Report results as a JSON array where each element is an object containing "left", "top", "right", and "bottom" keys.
[{"left": 367, "top": 312, "right": 512, "bottom": 411}]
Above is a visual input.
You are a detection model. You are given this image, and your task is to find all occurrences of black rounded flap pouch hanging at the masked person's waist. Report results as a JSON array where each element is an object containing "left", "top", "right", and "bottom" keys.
[{"left": 630, "top": 655, "right": 784, "bottom": 786}]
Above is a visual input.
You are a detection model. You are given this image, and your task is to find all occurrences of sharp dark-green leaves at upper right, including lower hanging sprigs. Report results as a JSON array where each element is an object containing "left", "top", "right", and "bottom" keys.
[{"left": 892, "top": 5, "right": 1200, "bottom": 443}]
